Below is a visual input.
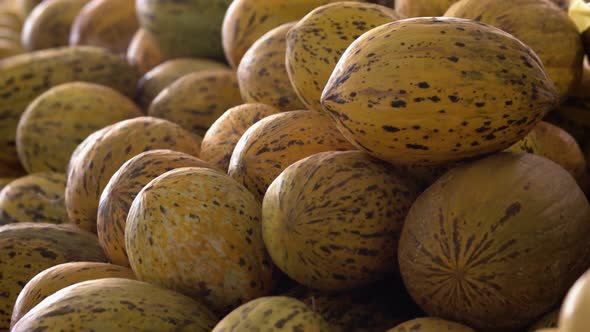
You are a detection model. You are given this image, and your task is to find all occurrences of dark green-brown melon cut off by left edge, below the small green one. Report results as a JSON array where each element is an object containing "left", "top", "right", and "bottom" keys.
[{"left": 0, "top": 223, "right": 106, "bottom": 330}]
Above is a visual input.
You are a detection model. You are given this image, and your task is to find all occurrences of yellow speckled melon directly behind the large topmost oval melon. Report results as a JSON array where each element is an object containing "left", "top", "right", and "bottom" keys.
[{"left": 286, "top": 1, "right": 402, "bottom": 111}]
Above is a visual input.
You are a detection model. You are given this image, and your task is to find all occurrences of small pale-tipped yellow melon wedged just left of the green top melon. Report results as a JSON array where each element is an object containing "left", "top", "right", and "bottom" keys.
[{"left": 126, "top": 29, "right": 165, "bottom": 74}]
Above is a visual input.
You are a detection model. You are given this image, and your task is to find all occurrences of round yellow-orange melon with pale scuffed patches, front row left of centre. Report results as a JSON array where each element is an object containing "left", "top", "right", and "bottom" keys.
[{"left": 125, "top": 167, "right": 274, "bottom": 314}]
